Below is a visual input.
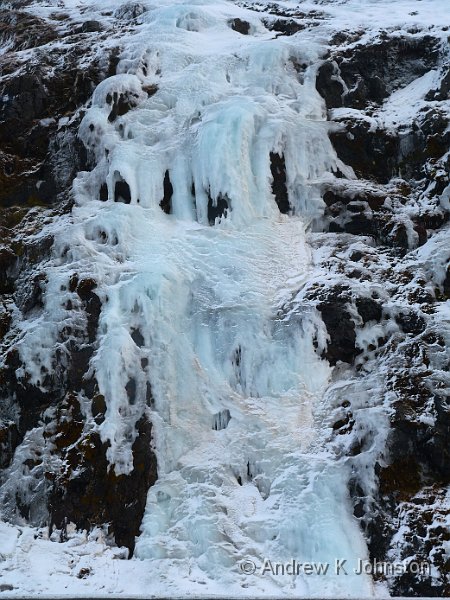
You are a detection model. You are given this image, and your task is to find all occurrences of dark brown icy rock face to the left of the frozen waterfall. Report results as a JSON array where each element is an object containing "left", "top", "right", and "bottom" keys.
[{"left": 0, "top": 2, "right": 157, "bottom": 556}]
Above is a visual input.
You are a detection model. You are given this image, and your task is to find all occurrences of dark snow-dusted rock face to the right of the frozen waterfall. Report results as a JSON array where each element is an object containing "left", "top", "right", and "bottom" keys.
[{"left": 309, "top": 27, "right": 450, "bottom": 596}]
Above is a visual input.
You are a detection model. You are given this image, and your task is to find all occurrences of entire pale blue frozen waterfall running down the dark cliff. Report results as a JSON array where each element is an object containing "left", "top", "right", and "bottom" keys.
[{"left": 22, "top": 2, "right": 373, "bottom": 596}]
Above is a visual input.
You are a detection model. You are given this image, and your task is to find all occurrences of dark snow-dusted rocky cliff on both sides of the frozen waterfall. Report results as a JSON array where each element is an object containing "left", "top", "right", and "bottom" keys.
[{"left": 0, "top": 0, "right": 450, "bottom": 596}]
